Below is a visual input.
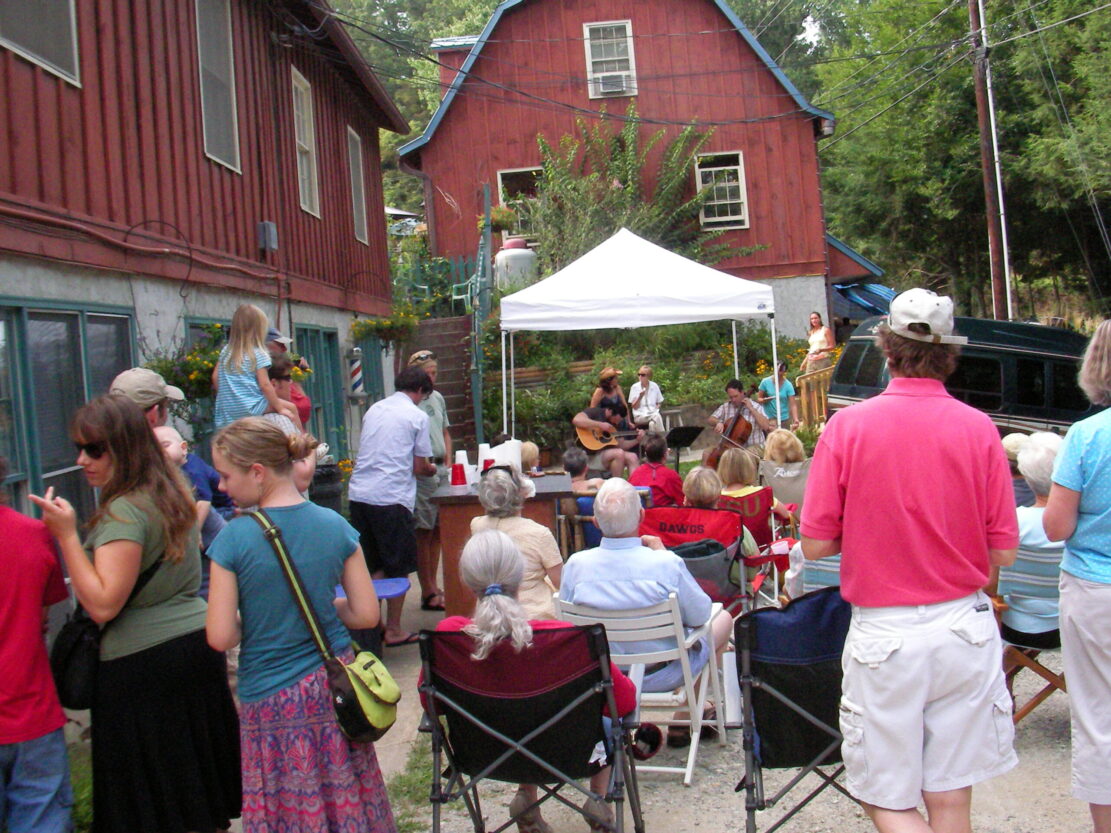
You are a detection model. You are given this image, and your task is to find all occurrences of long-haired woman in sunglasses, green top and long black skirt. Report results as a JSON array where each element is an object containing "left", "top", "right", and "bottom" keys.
[{"left": 31, "top": 395, "right": 241, "bottom": 833}]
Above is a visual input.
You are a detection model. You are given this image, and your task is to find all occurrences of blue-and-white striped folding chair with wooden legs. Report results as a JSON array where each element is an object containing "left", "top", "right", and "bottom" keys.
[{"left": 995, "top": 548, "right": 1067, "bottom": 723}]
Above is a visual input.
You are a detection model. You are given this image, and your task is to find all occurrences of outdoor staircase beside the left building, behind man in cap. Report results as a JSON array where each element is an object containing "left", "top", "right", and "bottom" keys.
[{"left": 408, "top": 315, "right": 478, "bottom": 453}]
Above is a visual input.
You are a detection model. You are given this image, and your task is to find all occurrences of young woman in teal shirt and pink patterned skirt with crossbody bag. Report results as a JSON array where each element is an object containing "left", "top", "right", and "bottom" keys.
[{"left": 207, "top": 417, "right": 397, "bottom": 833}]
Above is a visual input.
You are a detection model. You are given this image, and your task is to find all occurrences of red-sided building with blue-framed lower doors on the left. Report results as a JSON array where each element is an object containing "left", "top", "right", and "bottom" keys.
[{"left": 0, "top": 0, "right": 408, "bottom": 513}]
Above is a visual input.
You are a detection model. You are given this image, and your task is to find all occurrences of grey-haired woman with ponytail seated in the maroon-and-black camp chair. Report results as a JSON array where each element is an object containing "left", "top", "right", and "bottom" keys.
[{"left": 436, "top": 530, "right": 637, "bottom": 833}]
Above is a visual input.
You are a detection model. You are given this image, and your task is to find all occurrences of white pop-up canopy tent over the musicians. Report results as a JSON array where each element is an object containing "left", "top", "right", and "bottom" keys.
[{"left": 501, "top": 229, "right": 779, "bottom": 431}]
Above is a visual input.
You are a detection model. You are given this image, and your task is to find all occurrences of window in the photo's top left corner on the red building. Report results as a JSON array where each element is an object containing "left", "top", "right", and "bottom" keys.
[{"left": 0, "top": 0, "right": 81, "bottom": 87}]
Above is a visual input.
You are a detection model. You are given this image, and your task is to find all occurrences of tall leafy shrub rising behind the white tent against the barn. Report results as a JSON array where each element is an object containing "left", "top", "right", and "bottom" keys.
[{"left": 521, "top": 102, "right": 755, "bottom": 275}]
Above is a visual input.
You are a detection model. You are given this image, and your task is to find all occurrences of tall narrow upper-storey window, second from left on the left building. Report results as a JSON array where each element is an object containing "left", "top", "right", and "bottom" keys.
[{"left": 197, "top": 0, "right": 240, "bottom": 173}]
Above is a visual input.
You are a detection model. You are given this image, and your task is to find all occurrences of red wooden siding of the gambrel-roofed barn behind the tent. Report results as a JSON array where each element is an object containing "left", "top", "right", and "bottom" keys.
[{"left": 413, "top": 0, "right": 825, "bottom": 278}]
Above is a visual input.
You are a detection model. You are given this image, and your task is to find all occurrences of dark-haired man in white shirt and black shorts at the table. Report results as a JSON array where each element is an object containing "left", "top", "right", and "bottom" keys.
[{"left": 348, "top": 367, "right": 437, "bottom": 648}]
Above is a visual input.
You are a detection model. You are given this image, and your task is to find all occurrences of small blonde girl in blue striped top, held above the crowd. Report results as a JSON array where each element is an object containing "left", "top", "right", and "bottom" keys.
[{"left": 212, "top": 303, "right": 301, "bottom": 431}]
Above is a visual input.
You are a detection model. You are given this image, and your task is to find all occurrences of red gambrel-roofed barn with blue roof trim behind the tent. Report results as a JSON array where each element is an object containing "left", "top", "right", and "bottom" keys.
[{"left": 400, "top": 0, "right": 879, "bottom": 335}]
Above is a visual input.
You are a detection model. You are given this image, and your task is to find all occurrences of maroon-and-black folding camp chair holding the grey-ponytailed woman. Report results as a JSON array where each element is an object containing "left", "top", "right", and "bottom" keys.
[{"left": 420, "top": 624, "right": 644, "bottom": 833}]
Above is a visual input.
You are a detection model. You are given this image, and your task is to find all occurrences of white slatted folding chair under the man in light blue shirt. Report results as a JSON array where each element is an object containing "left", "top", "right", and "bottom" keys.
[{"left": 552, "top": 593, "right": 727, "bottom": 786}]
